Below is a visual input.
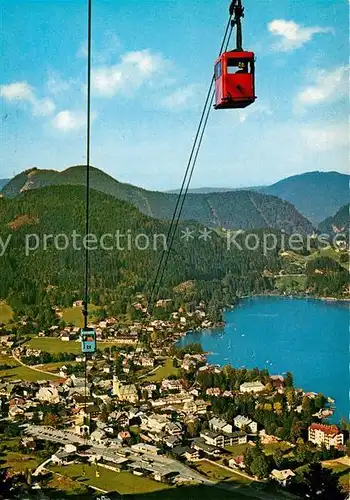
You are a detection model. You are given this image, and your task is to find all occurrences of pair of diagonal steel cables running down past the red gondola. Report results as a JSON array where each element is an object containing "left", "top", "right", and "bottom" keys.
[{"left": 147, "top": 16, "right": 233, "bottom": 312}]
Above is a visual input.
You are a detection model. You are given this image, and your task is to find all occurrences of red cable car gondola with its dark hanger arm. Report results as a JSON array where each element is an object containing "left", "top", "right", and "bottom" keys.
[{"left": 214, "top": 0, "right": 256, "bottom": 109}]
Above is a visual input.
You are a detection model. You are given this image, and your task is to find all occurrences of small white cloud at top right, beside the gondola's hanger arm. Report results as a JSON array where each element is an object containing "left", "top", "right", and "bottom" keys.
[{"left": 267, "top": 19, "right": 332, "bottom": 52}]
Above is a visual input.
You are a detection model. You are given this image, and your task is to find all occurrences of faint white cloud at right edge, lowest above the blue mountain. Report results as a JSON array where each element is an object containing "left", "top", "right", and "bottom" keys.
[{"left": 301, "top": 123, "right": 349, "bottom": 151}]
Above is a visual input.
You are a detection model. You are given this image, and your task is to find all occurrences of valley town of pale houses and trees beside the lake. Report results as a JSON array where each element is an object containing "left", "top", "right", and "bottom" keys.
[{"left": 0, "top": 299, "right": 349, "bottom": 498}]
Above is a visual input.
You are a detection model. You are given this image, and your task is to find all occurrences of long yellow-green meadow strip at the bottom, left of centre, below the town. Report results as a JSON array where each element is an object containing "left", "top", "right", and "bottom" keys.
[{"left": 50, "top": 464, "right": 169, "bottom": 495}]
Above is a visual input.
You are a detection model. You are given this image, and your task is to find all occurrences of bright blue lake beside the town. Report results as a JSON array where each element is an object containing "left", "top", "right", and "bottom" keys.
[{"left": 178, "top": 297, "right": 350, "bottom": 421}]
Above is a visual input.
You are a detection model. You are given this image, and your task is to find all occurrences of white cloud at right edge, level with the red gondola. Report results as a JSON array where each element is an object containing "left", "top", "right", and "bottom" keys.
[{"left": 296, "top": 66, "right": 349, "bottom": 106}]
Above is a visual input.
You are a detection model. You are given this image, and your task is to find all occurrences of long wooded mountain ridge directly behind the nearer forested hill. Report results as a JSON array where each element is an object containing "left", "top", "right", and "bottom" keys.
[{"left": 2, "top": 166, "right": 313, "bottom": 234}]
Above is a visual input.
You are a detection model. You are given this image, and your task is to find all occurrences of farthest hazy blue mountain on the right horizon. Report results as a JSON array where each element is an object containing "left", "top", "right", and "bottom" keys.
[{"left": 167, "top": 171, "right": 350, "bottom": 226}]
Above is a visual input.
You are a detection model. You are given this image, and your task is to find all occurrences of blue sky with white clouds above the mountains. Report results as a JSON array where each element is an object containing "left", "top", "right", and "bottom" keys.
[{"left": 0, "top": 0, "right": 349, "bottom": 190}]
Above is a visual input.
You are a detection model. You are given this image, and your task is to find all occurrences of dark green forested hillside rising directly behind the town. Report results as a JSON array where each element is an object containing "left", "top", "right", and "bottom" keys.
[{"left": 0, "top": 186, "right": 280, "bottom": 314}]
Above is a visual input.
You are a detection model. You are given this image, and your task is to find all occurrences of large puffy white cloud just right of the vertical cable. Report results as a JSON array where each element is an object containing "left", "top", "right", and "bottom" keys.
[{"left": 92, "top": 49, "right": 167, "bottom": 97}]
